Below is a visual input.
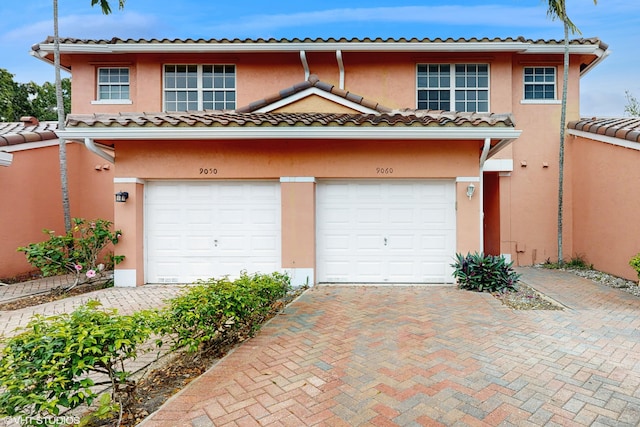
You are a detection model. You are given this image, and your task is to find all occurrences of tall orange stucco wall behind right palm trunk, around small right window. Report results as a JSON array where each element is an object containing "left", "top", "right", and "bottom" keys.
[{"left": 492, "top": 55, "right": 579, "bottom": 265}]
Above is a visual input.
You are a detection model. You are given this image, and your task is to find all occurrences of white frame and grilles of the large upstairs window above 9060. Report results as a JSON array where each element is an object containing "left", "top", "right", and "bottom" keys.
[{"left": 416, "top": 63, "right": 491, "bottom": 113}]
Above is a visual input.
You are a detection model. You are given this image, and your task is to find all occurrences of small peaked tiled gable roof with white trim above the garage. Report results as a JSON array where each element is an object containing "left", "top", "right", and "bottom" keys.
[{"left": 236, "top": 74, "right": 391, "bottom": 113}]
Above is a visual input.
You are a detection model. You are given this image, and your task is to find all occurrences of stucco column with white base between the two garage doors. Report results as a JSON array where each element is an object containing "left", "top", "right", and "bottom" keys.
[{"left": 280, "top": 177, "right": 316, "bottom": 286}]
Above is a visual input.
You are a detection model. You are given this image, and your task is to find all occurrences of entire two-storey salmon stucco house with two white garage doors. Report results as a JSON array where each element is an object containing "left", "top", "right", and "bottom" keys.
[{"left": 32, "top": 38, "right": 607, "bottom": 286}]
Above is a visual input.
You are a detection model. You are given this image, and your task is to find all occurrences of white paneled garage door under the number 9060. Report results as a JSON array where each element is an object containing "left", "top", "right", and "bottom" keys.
[{"left": 317, "top": 180, "right": 456, "bottom": 283}]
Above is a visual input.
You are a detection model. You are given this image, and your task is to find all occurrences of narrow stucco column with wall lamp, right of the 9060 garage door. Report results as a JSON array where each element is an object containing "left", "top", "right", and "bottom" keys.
[{"left": 456, "top": 177, "right": 483, "bottom": 254}]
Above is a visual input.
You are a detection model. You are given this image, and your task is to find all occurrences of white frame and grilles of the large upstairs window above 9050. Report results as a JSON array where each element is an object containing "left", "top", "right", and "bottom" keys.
[{"left": 162, "top": 64, "right": 237, "bottom": 112}]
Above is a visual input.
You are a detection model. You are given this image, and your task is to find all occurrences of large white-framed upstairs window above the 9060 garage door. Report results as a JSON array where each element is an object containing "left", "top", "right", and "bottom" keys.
[{"left": 418, "top": 64, "right": 489, "bottom": 113}]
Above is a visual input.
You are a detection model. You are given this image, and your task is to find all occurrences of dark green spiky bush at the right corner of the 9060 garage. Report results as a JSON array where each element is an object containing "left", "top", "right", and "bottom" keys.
[{"left": 451, "top": 252, "right": 520, "bottom": 292}]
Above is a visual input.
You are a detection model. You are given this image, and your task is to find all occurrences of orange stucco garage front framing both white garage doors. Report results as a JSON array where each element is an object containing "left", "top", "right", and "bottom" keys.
[{"left": 110, "top": 140, "right": 481, "bottom": 285}]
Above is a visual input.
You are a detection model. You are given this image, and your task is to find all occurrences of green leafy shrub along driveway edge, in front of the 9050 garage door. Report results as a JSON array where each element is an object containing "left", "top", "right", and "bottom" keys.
[{"left": 158, "top": 272, "right": 290, "bottom": 352}]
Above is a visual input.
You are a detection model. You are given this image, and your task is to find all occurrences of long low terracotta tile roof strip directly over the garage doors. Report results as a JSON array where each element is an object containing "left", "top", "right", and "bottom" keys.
[{"left": 66, "top": 110, "right": 514, "bottom": 128}]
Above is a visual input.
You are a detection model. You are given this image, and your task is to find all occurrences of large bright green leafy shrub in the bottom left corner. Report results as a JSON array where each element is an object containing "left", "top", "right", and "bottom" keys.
[{"left": 0, "top": 301, "right": 152, "bottom": 419}]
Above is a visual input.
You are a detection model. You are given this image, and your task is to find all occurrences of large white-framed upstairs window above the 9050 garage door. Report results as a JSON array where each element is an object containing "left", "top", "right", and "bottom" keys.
[{"left": 164, "top": 65, "right": 236, "bottom": 111}]
